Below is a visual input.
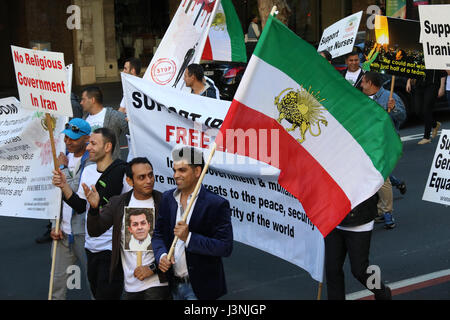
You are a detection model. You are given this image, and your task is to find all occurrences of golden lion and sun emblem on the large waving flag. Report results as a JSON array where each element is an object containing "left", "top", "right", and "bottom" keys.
[{"left": 275, "top": 86, "right": 328, "bottom": 143}]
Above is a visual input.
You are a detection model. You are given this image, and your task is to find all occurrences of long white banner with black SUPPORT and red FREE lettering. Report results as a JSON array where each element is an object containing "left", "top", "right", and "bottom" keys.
[{"left": 122, "top": 74, "right": 324, "bottom": 281}]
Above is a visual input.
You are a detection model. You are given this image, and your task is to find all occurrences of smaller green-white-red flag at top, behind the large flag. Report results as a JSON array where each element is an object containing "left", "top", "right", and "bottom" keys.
[{"left": 202, "top": 0, "right": 247, "bottom": 62}]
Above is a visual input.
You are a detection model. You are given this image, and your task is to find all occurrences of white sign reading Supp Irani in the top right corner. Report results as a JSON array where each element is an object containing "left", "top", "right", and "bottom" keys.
[{"left": 419, "top": 4, "right": 450, "bottom": 70}]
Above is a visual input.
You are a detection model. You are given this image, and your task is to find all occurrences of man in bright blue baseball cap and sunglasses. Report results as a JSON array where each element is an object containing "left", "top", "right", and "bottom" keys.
[{"left": 50, "top": 118, "right": 91, "bottom": 300}]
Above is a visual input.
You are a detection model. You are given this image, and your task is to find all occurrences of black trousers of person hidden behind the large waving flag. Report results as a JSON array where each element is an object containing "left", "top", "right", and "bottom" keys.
[{"left": 325, "top": 229, "right": 391, "bottom": 300}]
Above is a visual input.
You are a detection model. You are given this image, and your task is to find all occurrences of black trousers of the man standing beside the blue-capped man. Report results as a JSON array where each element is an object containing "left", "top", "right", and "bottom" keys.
[{"left": 86, "top": 250, "right": 123, "bottom": 300}]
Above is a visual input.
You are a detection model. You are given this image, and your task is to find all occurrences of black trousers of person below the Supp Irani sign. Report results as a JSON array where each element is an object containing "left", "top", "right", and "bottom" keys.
[{"left": 414, "top": 84, "right": 439, "bottom": 139}]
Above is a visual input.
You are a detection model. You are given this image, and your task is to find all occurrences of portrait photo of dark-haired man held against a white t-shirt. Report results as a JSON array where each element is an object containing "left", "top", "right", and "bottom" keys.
[{"left": 123, "top": 207, "right": 155, "bottom": 251}]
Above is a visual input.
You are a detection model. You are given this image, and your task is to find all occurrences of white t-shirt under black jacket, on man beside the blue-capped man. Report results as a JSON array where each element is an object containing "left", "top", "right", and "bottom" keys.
[{"left": 77, "top": 164, "right": 131, "bottom": 253}]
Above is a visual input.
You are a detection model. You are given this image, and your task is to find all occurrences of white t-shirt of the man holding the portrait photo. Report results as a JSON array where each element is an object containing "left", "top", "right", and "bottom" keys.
[{"left": 120, "top": 193, "right": 168, "bottom": 292}]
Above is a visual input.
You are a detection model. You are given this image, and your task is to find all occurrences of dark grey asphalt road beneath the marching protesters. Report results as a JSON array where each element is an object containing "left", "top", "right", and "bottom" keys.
[{"left": 0, "top": 85, "right": 450, "bottom": 300}]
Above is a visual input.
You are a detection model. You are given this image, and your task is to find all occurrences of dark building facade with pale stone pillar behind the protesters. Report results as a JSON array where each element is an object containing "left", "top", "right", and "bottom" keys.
[{"left": 0, "top": 0, "right": 450, "bottom": 93}]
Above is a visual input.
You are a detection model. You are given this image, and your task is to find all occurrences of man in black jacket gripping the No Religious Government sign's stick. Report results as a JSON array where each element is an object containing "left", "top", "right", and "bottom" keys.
[{"left": 53, "top": 128, "right": 130, "bottom": 300}]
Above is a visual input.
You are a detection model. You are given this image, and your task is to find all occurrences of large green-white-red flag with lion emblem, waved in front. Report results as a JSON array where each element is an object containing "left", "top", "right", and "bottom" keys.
[{"left": 217, "top": 16, "right": 402, "bottom": 237}]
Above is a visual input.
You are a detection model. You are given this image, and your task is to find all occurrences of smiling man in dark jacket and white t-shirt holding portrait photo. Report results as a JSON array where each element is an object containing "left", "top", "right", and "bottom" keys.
[{"left": 85, "top": 158, "right": 171, "bottom": 300}]
